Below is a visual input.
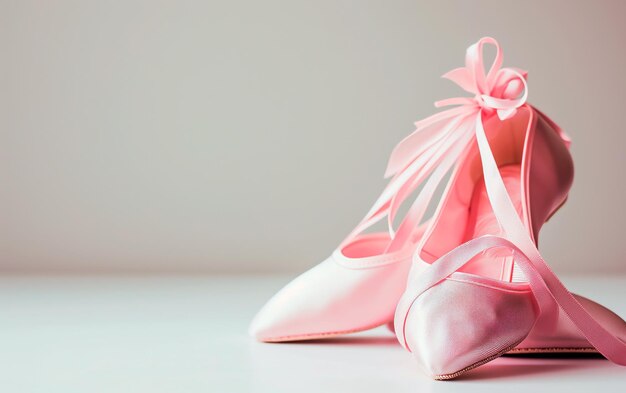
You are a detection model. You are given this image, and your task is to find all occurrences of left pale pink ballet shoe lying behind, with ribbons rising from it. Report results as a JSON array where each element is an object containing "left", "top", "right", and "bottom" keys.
[{"left": 249, "top": 71, "right": 439, "bottom": 342}]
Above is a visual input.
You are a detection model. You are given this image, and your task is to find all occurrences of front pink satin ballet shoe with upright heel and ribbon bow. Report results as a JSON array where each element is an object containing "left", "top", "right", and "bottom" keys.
[{"left": 395, "top": 38, "right": 626, "bottom": 379}]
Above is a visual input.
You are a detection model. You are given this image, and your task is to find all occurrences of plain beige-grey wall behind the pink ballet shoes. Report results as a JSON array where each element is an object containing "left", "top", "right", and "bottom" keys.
[{"left": 0, "top": 0, "right": 626, "bottom": 273}]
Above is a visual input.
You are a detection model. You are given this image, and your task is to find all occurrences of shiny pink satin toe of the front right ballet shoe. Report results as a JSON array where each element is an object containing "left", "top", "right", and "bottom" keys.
[{"left": 405, "top": 272, "right": 538, "bottom": 376}]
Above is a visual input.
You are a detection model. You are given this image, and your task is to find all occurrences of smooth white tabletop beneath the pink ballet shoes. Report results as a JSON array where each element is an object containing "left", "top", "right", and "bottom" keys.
[{"left": 0, "top": 275, "right": 626, "bottom": 393}]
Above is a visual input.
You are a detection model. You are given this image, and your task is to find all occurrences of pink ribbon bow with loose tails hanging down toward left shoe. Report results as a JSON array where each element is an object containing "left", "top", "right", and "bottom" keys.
[{"left": 342, "top": 38, "right": 536, "bottom": 245}]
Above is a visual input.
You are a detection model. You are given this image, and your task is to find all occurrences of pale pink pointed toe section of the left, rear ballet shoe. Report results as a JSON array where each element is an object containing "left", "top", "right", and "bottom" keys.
[{"left": 249, "top": 257, "right": 406, "bottom": 342}]
